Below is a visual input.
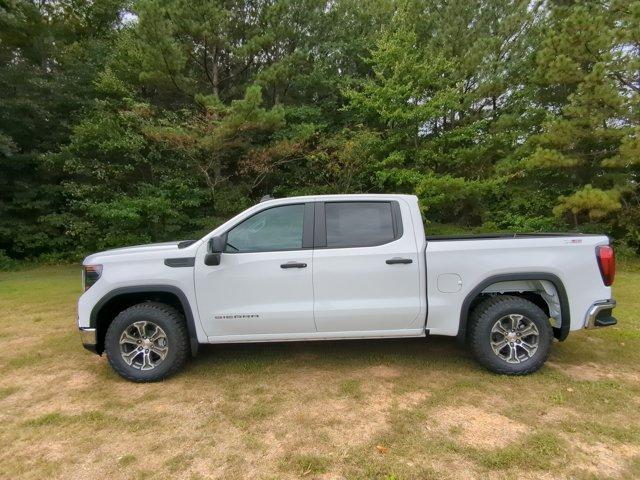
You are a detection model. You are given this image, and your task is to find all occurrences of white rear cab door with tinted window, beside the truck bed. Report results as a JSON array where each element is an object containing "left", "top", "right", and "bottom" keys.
[{"left": 313, "top": 201, "right": 420, "bottom": 334}]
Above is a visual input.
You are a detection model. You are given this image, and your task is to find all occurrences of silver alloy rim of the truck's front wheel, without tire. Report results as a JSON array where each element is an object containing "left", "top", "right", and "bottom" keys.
[{"left": 120, "top": 321, "right": 169, "bottom": 370}]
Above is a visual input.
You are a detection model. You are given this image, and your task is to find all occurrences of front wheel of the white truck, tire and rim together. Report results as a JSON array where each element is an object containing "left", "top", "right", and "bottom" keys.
[{"left": 105, "top": 302, "right": 189, "bottom": 382}]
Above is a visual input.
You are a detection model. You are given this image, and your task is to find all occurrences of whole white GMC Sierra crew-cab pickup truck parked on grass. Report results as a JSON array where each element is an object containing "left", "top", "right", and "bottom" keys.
[{"left": 78, "top": 195, "right": 616, "bottom": 381}]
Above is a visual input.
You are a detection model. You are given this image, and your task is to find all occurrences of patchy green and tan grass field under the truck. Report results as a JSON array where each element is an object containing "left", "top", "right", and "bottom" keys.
[{"left": 0, "top": 263, "right": 640, "bottom": 480}]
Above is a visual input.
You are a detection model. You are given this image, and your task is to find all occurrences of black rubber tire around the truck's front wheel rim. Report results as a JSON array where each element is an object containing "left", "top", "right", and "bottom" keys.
[{"left": 104, "top": 302, "right": 189, "bottom": 382}]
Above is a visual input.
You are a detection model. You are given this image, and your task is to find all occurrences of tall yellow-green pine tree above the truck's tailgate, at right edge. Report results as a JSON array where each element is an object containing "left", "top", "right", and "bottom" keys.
[{"left": 526, "top": 2, "right": 638, "bottom": 231}]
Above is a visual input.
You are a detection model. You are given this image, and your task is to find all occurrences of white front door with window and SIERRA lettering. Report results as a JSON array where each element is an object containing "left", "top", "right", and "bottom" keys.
[{"left": 195, "top": 203, "right": 316, "bottom": 340}]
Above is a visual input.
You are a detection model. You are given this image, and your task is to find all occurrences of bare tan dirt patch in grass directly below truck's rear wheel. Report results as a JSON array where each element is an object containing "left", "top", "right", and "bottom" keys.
[{"left": 434, "top": 405, "right": 527, "bottom": 448}]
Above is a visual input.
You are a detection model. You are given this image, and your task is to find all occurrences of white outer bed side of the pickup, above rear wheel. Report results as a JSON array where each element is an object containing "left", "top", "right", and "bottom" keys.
[{"left": 425, "top": 232, "right": 611, "bottom": 335}]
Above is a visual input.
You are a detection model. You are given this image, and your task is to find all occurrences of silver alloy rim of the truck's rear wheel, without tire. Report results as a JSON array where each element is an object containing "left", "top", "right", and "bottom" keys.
[{"left": 490, "top": 313, "right": 540, "bottom": 363}]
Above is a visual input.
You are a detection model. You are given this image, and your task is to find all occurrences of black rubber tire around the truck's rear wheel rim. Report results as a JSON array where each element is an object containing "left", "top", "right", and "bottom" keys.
[{"left": 469, "top": 295, "right": 553, "bottom": 375}]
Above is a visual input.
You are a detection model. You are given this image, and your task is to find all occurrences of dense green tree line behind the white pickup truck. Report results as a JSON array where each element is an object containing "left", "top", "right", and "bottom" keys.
[{"left": 0, "top": 0, "right": 640, "bottom": 263}]
